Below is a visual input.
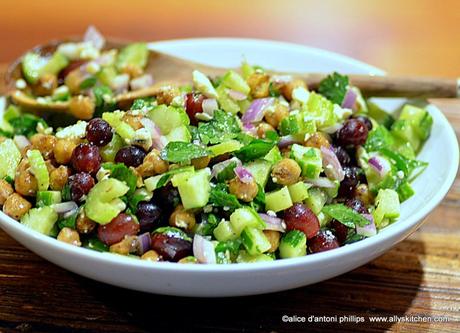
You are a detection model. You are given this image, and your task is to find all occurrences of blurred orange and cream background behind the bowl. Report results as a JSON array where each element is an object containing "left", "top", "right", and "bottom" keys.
[{"left": 0, "top": 0, "right": 460, "bottom": 77}]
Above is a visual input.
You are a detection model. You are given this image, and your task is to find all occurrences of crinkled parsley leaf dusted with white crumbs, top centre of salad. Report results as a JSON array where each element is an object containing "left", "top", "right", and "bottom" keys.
[{"left": 198, "top": 110, "right": 241, "bottom": 144}]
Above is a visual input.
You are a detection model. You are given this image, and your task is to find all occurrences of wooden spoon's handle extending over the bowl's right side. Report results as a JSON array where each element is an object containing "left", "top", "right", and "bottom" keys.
[{"left": 303, "top": 74, "right": 460, "bottom": 98}]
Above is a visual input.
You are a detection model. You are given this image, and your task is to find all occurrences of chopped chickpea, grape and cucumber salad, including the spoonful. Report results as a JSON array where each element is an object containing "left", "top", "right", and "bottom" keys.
[{"left": 0, "top": 31, "right": 433, "bottom": 264}]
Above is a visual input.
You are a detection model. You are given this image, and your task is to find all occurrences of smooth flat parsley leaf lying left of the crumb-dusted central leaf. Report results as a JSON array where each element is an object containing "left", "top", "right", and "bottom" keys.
[{"left": 160, "top": 141, "right": 211, "bottom": 163}]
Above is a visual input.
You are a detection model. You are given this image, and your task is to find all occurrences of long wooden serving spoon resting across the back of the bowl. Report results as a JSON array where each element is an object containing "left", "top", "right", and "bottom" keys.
[{"left": 6, "top": 40, "right": 459, "bottom": 118}]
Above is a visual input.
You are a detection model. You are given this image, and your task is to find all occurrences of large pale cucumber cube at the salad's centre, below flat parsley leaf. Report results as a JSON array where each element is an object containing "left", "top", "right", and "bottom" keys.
[{"left": 173, "top": 168, "right": 211, "bottom": 209}]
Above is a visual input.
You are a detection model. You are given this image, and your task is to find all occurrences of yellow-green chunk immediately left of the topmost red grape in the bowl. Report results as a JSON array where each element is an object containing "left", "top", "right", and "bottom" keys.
[{"left": 147, "top": 104, "right": 190, "bottom": 135}]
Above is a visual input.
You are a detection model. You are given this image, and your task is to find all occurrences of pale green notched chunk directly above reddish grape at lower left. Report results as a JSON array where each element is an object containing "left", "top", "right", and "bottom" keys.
[{"left": 85, "top": 178, "right": 129, "bottom": 224}]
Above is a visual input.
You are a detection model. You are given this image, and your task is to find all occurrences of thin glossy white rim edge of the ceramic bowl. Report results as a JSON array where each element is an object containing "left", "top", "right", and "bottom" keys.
[{"left": 0, "top": 38, "right": 459, "bottom": 273}]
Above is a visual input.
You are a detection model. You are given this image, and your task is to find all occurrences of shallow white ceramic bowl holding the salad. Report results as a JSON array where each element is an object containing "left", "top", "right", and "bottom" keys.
[{"left": 0, "top": 38, "right": 459, "bottom": 297}]
